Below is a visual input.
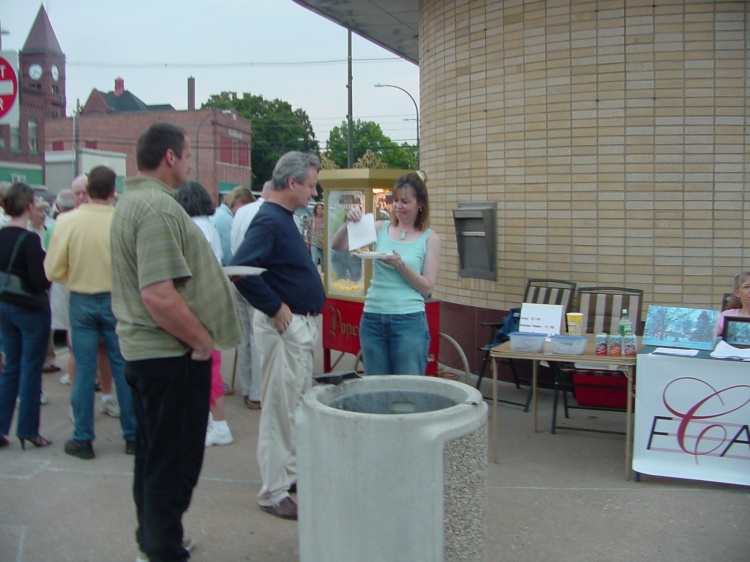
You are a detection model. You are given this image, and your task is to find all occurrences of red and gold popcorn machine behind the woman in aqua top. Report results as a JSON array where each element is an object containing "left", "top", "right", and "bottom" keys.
[{"left": 318, "top": 168, "right": 440, "bottom": 374}]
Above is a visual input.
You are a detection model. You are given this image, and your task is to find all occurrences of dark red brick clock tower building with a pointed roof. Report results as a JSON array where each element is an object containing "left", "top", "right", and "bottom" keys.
[{"left": 0, "top": 6, "right": 65, "bottom": 186}]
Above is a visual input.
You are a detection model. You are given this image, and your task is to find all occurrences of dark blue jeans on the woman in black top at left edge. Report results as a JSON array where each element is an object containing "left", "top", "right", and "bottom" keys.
[{"left": 0, "top": 302, "right": 51, "bottom": 438}]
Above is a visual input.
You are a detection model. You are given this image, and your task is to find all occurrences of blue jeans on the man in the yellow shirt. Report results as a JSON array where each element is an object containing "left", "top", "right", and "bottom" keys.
[{"left": 70, "top": 291, "right": 135, "bottom": 441}]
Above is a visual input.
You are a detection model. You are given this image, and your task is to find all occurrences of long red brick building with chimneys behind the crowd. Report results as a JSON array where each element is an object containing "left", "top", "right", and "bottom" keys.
[{"left": 45, "top": 78, "right": 252, "bottom": 199}]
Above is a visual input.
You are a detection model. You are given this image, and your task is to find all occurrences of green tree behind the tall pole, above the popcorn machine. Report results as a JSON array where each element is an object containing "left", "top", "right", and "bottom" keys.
[{"left": 326, "top": 119, "right": 416, "bottom": 169}]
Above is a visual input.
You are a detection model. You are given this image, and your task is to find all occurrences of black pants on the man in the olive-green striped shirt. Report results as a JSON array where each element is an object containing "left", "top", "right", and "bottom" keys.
[{"left": 125, "top": 355, "right": 211, "bottom": 562}]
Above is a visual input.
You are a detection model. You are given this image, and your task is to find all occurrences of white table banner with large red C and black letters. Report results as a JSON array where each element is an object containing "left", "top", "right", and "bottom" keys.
[{"left": 633, "top": 355, "right": 750, "bottom": 485}]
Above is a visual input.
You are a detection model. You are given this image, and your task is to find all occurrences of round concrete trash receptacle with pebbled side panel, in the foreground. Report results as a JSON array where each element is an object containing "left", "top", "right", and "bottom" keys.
[{"left": 296, "top": 376, "right": 487, "bottom": 562}]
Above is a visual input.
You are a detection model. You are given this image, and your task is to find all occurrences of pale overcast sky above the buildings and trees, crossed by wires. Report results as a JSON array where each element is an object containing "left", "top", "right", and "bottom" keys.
[{"left": 0, "top": 0, "right": 419, "bottom": 148}]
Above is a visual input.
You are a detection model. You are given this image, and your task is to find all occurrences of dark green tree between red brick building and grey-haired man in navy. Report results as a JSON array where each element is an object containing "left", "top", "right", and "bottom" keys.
[{"left": 203, "top": 92, "right": 320, "bottom": 189}]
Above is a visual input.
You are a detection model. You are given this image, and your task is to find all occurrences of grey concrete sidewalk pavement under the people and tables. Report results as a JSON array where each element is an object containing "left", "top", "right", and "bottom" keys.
[{"left": 0, "top": 346, "right": 750, "bottom": 562}]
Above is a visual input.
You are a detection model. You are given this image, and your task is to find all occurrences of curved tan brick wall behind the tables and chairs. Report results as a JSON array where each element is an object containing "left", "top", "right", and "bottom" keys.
[{"left": 420, "top": 0, "right": 750, "bottom": 308}]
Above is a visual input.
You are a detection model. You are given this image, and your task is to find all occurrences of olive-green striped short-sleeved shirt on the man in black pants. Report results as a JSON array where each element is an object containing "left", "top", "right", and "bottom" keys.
[{"left": 112, "top": 177, "right": 238, "bottom": 361}]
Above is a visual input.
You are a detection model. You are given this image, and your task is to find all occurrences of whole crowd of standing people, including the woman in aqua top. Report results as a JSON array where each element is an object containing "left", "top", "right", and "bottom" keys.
[{"left": 0, "top": 123, "right": 440, "bottom": 562}]
